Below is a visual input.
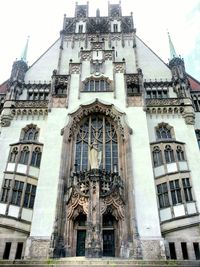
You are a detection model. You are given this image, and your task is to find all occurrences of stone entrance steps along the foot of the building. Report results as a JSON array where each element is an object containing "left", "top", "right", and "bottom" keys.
[{"left": 0, "top": 257, "right": 200, "bottom": 267}]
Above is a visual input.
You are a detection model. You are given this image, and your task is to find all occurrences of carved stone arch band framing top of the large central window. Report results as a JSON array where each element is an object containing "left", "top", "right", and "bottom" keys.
[{"left": 69, "top": 99, "right": 124, "bottom": 140}]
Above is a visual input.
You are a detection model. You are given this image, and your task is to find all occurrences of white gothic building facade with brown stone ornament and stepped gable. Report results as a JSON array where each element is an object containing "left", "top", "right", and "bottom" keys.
[{"left": 0, "top": 3, "right": 200, "bottom": 259}]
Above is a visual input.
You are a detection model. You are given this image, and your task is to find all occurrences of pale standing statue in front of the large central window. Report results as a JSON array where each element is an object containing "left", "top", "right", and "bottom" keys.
[{"left": 89, "top": 140, "right": 102, "bottom": 170}]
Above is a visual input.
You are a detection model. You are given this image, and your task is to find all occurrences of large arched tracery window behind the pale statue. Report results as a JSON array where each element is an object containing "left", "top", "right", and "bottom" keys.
[{"left": 75, "top": 114, "right": 118, "bottom": 171}]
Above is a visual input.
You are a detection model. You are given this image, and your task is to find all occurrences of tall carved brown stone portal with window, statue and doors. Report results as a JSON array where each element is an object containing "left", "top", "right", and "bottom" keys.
[{"left": 51, "top": 99, "right": 136, "bottom": 257}]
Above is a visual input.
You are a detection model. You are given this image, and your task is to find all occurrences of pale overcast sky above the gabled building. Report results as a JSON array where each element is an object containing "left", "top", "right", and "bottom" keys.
[{"left": 0, "top": 0, "right": 200, "bottom": 83}]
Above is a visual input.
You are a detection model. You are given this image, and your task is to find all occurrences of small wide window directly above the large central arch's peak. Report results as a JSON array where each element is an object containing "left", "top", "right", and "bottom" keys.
[{"left": 84, "top": 79, "right": 111, "bottom": 92}]
